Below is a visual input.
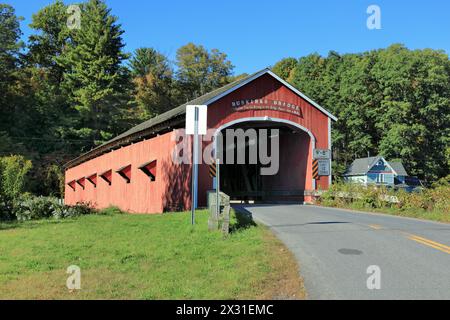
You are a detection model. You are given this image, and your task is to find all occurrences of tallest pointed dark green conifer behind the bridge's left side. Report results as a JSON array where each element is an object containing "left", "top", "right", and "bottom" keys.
[{"left": 57, "top": 0, "right": 130, "bottom": 142}]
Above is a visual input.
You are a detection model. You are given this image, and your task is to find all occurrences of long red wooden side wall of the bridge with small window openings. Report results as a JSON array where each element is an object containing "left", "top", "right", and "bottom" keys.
[{"left": 65, "top": 133, "right": 190, "bottom": 213}]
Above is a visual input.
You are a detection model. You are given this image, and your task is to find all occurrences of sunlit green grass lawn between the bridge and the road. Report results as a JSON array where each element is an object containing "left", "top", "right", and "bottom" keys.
[{"left": 0, "top": 211, "right": 305, "bottom": 299}]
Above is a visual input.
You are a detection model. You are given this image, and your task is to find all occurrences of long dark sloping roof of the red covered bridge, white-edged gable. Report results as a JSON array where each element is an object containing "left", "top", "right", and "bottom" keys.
[{"left": 65, "top": 68, "right": 337, "bottom": 169}]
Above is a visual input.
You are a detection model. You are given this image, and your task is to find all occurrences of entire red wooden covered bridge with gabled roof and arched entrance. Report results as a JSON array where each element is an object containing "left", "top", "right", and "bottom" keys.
[{"left": 65, "top": 69, "right": 336, "bottom": 213}]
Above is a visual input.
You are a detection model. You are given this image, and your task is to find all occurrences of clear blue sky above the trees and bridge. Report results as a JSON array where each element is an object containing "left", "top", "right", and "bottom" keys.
[{"left": 6, "top": 0, "right": 450, "bottom": 74}]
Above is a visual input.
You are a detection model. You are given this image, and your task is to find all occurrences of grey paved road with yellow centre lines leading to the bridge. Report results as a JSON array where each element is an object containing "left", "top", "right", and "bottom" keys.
[{"left": 239, "top": 205, "right": 450, "bottom": 299}]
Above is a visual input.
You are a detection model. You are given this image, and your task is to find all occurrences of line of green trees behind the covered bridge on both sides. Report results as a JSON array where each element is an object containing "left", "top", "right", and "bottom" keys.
[{"left": 0, "top": 0, "right": 450, "bottom": 196}]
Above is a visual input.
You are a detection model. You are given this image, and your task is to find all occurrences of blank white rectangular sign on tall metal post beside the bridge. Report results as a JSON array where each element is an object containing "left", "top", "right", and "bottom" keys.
[{"left": 186, "top": 105, "right": 207, "bottom": 225}]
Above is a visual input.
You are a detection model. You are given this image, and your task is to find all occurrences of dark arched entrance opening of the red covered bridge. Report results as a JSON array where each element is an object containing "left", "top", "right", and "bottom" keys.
[{"left": 220, "top": 121, "right": 311, "bottom": 201}]
